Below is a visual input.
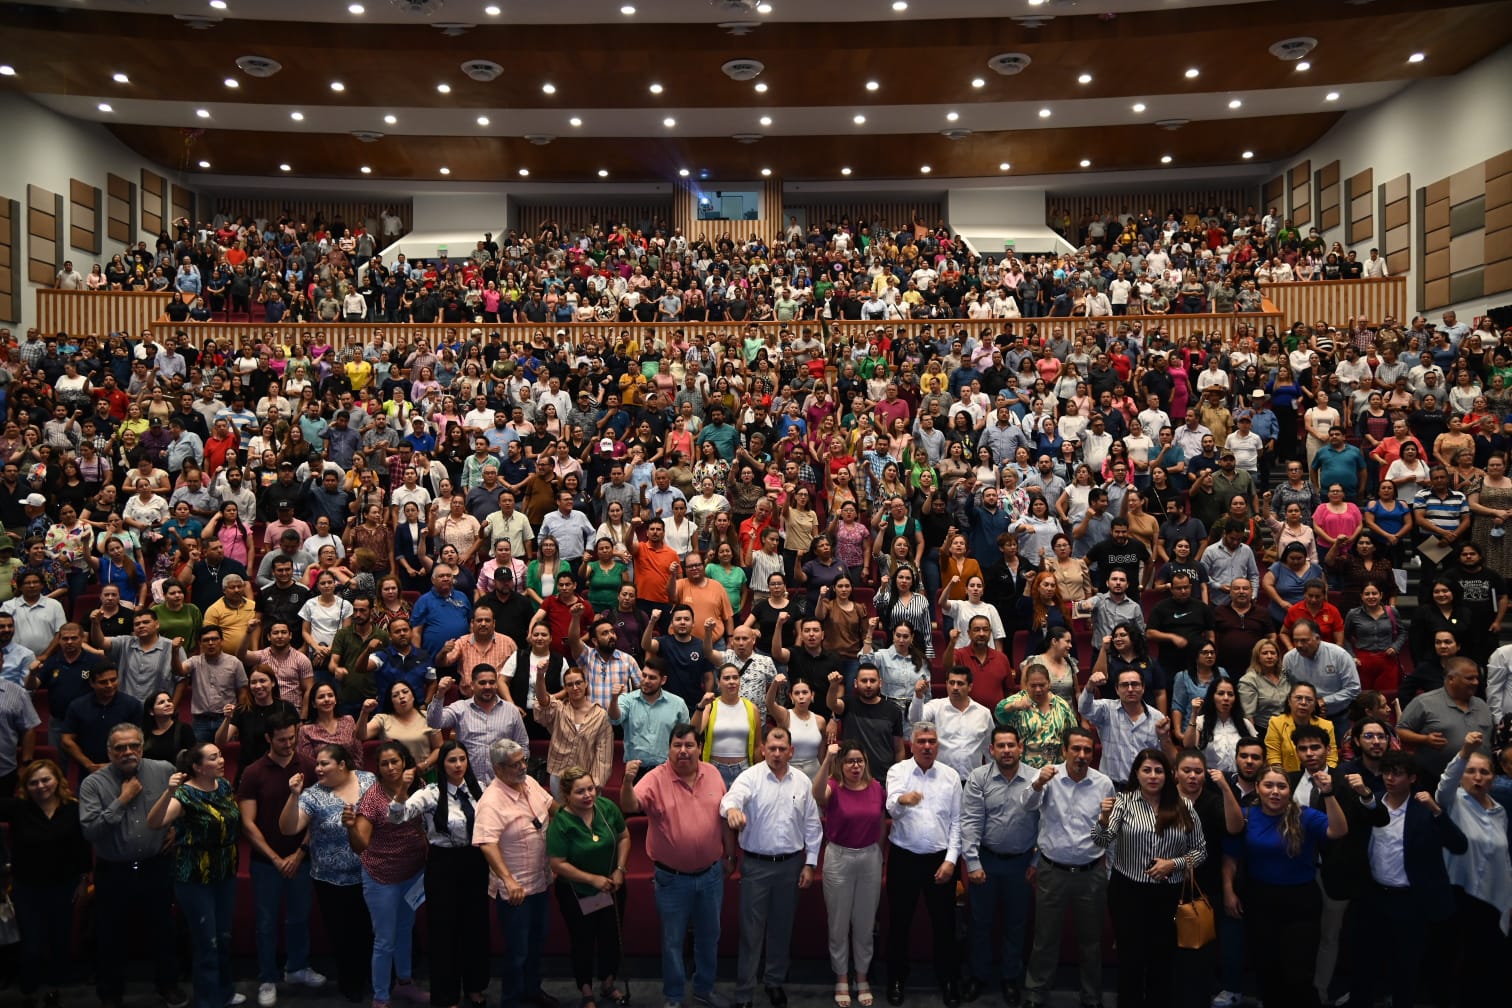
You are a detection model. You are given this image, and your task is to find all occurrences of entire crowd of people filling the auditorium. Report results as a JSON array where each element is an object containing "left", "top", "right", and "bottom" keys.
[{"left": 0, "top": 216, "right": 1512, "bottom": 1008}]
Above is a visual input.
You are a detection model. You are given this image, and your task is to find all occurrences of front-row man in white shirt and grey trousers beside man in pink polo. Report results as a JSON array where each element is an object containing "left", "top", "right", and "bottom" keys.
[{"left": 720, "top": 728, "right": 816, "bottom": 1008}]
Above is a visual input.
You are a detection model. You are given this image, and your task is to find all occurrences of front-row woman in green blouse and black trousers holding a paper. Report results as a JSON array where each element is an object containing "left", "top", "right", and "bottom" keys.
[{"left": 546, "top": 766, "right": 631, "bottom": 1008}]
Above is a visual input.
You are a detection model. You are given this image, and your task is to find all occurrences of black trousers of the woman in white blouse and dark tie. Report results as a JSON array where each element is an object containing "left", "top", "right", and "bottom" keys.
[{"left": 425, "top": 845, "right": 493, "bottom": 1005}]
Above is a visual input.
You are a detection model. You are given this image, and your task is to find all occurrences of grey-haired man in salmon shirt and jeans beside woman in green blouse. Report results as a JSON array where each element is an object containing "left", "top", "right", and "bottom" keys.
[{"left": 471, "top": 737, "right": 556, "bottom": 1008}]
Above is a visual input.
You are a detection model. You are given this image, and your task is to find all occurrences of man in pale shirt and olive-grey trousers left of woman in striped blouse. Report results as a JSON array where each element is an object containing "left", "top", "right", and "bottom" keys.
[{"left": 1024, "top": 728, "right": 1113, "bottom": 1006}]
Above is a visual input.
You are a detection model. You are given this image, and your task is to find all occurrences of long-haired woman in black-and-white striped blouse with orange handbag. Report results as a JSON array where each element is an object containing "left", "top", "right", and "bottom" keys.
[{"left": 1092, "top": 750, "right": 1208, "bottom": 1008}]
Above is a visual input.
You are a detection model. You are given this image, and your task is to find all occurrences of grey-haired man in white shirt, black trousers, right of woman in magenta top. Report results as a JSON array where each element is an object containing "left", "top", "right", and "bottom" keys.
[{"left": 888, "top": 721, "right": 960, "bottom": 1008}]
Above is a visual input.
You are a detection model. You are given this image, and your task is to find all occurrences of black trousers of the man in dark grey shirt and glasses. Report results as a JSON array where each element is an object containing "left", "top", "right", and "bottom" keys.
[{"left": 95, "top": 855, "right": 178, "bottom": 1000}]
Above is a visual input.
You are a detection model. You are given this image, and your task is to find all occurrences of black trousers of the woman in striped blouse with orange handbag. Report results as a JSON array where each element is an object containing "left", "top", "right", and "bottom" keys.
[{"left": 1108, "top": 870, "right": 1181, "bottom": 1008}]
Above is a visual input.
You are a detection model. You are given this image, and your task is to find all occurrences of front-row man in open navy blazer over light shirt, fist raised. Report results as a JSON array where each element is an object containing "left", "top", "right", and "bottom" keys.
[{"left": 1349, "top": 753, "right": 1470, "bottom": 1005}]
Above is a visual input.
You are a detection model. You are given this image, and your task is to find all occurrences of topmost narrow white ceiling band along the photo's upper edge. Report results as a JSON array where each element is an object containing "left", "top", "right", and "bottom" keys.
[{"left": 11, "top": 0, "right": 1253, "bottom": 26}]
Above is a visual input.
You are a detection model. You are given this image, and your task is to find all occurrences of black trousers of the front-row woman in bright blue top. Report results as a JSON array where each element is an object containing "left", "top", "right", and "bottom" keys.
[{"left": 1245, "top": 880, "right": 1323, "bottom": 1008}]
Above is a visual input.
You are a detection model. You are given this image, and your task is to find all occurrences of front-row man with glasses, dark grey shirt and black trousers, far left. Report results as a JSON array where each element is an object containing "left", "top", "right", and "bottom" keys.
[{"left": 79, "top": 724, "right": 189, "bottom": 1008}]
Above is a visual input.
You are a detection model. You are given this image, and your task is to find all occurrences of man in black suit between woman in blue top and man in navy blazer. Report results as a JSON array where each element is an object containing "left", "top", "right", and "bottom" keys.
[{"left": 1287, "top": 725, "right": 1387, "bottom": 1005}]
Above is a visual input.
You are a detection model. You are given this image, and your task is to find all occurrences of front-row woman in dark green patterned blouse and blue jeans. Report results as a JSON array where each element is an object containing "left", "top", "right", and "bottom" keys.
[{"left": 147, "top": 742, "right": 242, "bottom": 1008}]
